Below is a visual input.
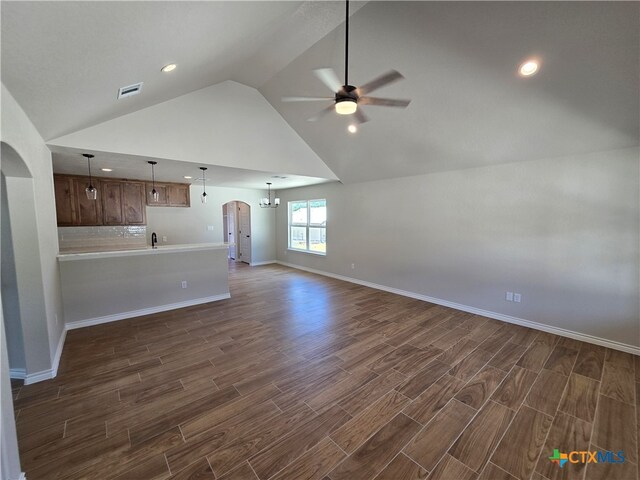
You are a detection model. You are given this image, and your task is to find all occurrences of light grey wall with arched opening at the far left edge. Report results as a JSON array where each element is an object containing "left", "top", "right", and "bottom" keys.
[{"left": 0, "top": 85, "right": 64, "bottom": 378}]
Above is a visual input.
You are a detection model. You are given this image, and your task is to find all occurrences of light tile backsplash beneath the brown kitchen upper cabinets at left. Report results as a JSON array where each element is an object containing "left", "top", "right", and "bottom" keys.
[{"left": 58, "top": 225, "right": 147, "bottom": 253}]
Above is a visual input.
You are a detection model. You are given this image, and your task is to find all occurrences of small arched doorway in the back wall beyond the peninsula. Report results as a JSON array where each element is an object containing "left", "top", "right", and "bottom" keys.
[{"left": 222, "top": 200, "right": 251, "bottom": 265}]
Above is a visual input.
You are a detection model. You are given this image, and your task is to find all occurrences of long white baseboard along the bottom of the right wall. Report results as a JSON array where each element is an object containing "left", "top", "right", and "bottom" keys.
[{"left": 276, "top": 260, "right": 640, "bottom": 355}]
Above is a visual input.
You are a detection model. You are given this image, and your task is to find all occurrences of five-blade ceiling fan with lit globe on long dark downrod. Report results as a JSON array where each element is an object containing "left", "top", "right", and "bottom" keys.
[{"left": 282, "top": 0, "right": 411, "bottom": 123}]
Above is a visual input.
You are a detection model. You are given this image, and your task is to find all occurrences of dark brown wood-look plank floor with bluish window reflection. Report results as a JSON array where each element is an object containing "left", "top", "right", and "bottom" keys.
[{"left": 13, "top": 264, "right": 640, "bottom": 480}]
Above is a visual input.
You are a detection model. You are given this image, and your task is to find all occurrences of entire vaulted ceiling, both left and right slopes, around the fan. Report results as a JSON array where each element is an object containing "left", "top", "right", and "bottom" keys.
[{"left": 0, "top": 1, "right": 640, "bottom": 186}]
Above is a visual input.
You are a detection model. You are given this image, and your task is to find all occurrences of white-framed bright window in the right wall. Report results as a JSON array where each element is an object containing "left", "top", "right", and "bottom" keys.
[{"left": 289, "top": 199, "right": 327, "bottom": 255}]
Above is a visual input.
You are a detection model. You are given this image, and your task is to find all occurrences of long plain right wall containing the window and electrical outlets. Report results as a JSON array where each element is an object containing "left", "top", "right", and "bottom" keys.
[{"left": 277, "top": 148, "right": 640, "bottom": 351}]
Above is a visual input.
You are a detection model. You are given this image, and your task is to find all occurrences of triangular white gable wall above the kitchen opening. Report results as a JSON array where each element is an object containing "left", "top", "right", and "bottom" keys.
[{"left": 47, "top": 81, "right": 336, "bottom": 179}]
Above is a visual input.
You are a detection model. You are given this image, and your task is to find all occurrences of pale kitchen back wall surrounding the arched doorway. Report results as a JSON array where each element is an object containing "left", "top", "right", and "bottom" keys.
[{"left": 147, "top": 185, "right": 275, "bottom": 264}]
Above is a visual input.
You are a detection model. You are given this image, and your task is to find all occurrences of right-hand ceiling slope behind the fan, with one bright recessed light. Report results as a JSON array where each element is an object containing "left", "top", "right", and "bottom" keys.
[{"left": 260, "top": 2, "right": 640, "bottom": 183}]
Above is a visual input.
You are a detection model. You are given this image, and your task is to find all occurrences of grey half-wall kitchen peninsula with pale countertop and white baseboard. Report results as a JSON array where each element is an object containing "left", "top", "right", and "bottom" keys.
[{"left": 58, "top": 243, "right": 230, "bottom": 328}]
